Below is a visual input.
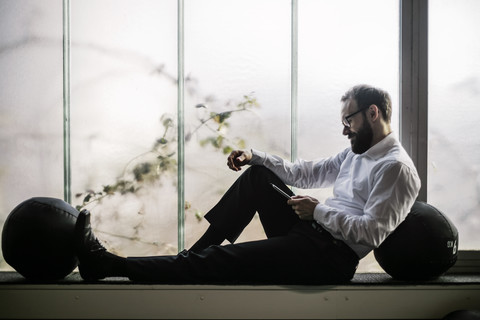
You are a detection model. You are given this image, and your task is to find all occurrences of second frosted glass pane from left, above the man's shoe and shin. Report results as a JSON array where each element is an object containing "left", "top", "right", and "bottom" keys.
[{"left": 71, "top": 0, "right": 177, "bottom": 255}]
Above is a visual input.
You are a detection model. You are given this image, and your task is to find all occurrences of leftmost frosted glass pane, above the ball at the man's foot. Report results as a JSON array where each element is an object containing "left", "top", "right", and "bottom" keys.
[{"left": 0, "top": 0, "right": 63, "bottom": 269}]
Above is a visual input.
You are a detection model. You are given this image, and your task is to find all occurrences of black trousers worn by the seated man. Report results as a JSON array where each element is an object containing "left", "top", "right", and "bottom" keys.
[{"left": 127, "top": 166, "right": 358, "bottom": 284}]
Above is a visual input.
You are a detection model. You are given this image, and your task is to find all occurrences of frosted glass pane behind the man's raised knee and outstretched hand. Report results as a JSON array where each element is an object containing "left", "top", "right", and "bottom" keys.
[{"left": 185, "top": 0, "right": 291, "bottom": 247}]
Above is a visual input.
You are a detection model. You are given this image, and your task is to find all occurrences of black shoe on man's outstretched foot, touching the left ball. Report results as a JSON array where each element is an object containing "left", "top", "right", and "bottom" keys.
[{"left": 75, "top": 209, "right": 109, "bottom": 281}]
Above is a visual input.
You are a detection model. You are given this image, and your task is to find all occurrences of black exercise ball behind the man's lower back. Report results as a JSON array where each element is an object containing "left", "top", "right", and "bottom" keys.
[{"left": 374, "top": 201, "right": 458, "bottom": 280}]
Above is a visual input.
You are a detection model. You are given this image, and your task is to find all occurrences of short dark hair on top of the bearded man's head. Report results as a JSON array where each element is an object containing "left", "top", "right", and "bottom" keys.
[{"left": 341, "top": 84, "right": 392, "bottom": 122}]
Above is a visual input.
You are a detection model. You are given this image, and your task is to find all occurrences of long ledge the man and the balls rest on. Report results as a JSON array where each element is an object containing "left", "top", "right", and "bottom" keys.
[{"left": 0, "top": 272, "right": 480, "bottom": 319}]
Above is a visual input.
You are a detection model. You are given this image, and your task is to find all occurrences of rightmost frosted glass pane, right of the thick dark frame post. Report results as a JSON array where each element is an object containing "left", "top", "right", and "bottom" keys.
[{"left": 428, "top": 0, "right": 480, "bottom": 250}]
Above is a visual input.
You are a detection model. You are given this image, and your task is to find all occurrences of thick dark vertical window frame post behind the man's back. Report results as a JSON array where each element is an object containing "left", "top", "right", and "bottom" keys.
[{"left": 399, "top": 0, "right": 428, "bottom": 202}]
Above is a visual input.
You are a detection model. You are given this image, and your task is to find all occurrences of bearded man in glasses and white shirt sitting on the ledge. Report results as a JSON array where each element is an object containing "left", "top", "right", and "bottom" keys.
[{"left": 76, "top": 85, "right": 420, "bottom": 284}]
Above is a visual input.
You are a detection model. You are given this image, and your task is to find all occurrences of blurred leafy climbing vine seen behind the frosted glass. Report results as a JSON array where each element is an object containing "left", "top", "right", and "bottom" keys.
[{"left": 75, "top": 93, "right": 259, "bottom": 212}]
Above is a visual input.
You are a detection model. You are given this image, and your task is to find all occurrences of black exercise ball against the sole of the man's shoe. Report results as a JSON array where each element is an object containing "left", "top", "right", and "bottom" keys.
[{"left": 2, "top": 197, "right": 78, "bottom": 280}]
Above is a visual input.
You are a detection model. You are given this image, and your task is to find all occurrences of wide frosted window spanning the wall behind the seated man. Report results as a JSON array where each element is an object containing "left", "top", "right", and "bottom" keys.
[{"left": 0, "top": 0, "right": 480, "bottom": 271}]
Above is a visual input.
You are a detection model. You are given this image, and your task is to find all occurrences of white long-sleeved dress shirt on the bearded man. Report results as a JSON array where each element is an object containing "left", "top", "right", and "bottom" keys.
[{"left": 250, "top": 134, "right": 420, "bottom": 258}]
